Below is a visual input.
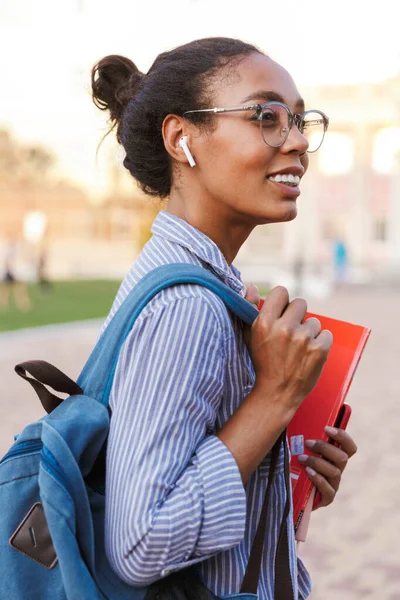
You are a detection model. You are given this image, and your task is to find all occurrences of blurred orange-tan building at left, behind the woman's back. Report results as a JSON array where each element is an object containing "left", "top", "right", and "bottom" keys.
[{"left": 0, "top": 134, "right": 158, "bottom": 279}]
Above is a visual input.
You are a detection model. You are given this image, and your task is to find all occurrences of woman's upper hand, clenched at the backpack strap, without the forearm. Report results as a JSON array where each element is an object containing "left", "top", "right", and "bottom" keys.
[{"left": 246, "top": 286, "right": 333, "bottom": 422}]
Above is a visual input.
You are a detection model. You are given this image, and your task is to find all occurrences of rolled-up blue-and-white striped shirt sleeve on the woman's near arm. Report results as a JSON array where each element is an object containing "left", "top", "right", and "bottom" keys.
[{"left": 106, "top": 296, "right": 246, "bottom": 587}]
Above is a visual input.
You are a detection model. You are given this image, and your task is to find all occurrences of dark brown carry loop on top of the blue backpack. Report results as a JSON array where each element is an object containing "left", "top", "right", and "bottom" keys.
[{"left": 15, "top": 360, "right": 83, "bottom": 413}]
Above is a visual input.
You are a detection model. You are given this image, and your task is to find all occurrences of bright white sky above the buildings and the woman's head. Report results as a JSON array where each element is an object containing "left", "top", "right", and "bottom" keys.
[{"left": 0, "top": 0, "right": 400, "bottom": 195}]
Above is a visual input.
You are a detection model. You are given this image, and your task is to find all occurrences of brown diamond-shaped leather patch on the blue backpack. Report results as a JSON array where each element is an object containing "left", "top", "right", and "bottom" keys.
[{"left": 10, "top": 502, "right": 57, "bottom": 569}]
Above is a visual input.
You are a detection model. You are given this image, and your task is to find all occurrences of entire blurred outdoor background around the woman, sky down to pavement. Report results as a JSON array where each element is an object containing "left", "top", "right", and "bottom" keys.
[{"left": 0, "top": 0, "right": 400, "bottom": 600}]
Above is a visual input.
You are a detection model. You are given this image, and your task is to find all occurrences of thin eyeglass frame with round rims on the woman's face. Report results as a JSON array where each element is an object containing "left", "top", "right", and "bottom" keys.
[{"left": 182, "top": 100, "right": 329, "bottom": 154}]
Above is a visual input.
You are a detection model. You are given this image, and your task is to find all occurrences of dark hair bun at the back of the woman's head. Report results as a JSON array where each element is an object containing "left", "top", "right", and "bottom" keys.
[{"left": 92, "top": 54, "right": 143, "bottom": 125}]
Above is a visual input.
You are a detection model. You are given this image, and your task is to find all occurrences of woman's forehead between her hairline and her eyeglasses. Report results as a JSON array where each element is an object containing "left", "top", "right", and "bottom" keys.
[{"left": 214, "top": 54, "right": 304, "bottom": 112}]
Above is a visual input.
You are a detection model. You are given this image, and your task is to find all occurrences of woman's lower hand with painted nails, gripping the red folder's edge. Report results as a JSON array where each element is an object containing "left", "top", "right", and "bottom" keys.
[{"left": 298, "top": 427, "right": 357, "bottom": 508}]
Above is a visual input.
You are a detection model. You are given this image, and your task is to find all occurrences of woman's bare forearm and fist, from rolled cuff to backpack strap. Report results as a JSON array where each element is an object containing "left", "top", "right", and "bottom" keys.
[{"left": 222, "top": 286, "right": 332, "bottom": 483}]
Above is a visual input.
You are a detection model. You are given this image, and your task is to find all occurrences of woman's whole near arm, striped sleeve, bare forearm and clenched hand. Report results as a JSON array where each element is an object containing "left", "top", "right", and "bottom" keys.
[{"left": 106, "top": 288, "right": 332, "bottom": 586}]
